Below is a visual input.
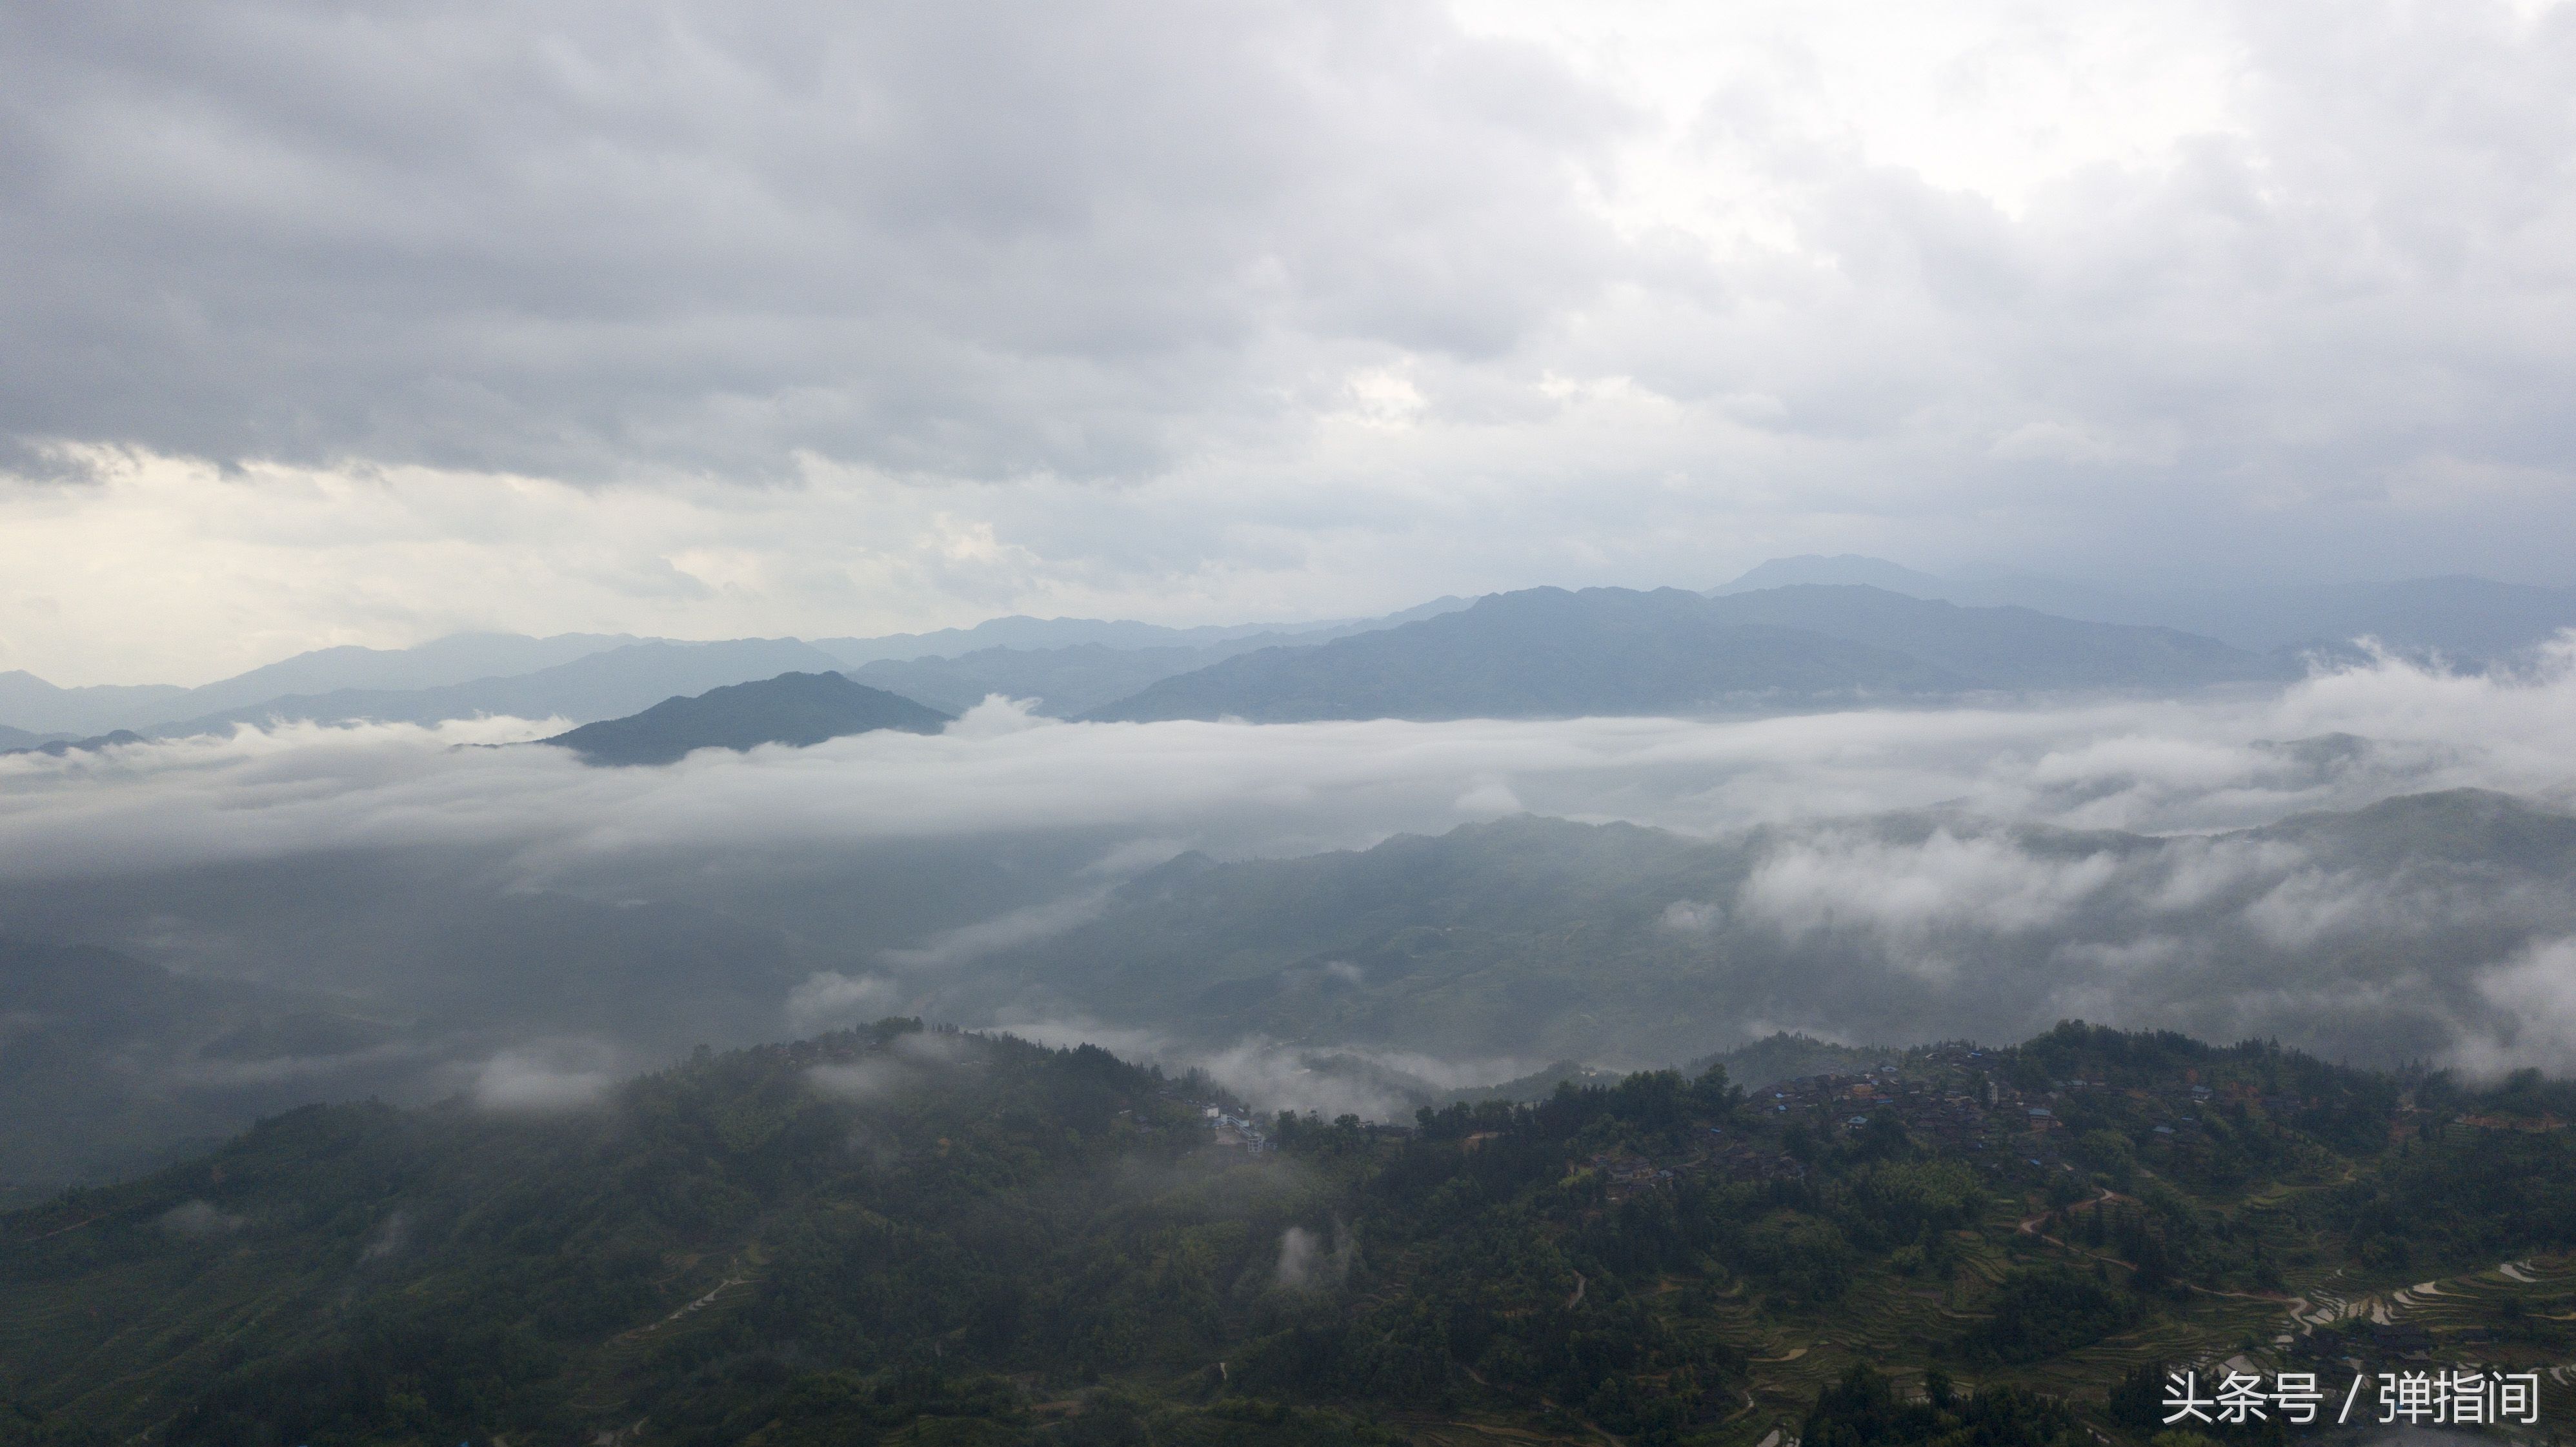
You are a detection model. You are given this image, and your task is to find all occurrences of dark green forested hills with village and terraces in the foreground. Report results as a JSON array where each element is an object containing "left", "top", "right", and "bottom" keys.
[{"left": 0, "top": 1020, "right": 2576, "bottom": 1447}]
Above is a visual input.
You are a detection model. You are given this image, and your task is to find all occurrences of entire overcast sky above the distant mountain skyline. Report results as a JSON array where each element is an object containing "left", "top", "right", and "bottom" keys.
[{"left": 0, "top": 0, "right": 2576, "bottom": 682}]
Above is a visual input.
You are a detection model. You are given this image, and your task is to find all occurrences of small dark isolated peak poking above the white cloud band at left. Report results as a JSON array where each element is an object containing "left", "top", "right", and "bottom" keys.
[{"left": 543, "top": 672, "right": 953, "bottom": 765}]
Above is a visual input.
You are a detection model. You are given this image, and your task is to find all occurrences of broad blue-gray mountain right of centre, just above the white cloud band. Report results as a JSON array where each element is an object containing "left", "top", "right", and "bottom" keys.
[{"left": 1092, "top": 585, "right": 2280, "bottom": 724}]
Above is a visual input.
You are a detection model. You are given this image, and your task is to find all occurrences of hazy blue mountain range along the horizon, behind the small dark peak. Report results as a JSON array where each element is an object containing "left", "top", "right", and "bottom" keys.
[{"left": 0, "top": 556, "right": 2576, "bottom": 749}]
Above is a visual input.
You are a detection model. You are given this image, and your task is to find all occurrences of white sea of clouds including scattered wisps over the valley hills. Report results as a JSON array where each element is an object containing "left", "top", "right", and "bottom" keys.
[{"left": 0, "top": 641, "right": 2576, "bottom": 1107}]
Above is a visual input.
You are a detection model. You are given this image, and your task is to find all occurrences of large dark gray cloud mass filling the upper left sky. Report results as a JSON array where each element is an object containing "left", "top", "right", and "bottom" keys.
[{"left": 0, "top": 0, "right": 1618, "bottom": 476}]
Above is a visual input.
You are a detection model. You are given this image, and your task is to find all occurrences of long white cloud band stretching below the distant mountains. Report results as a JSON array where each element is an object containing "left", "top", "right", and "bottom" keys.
[{"left": 0, "top": 643, "right": 2576, "bottom": 880}]
